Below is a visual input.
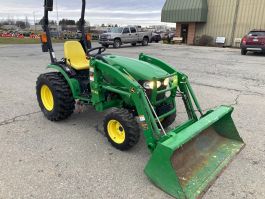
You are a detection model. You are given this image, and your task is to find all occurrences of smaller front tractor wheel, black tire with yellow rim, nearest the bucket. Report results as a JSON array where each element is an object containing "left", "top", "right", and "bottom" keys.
[{"left": 103, "top": 108, "right": 140, "bottom": 151}]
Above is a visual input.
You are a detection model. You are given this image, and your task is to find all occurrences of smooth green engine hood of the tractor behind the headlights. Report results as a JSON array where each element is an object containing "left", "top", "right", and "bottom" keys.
[{"left": 104, "top": 55, "right": 169, "bottom": 81}]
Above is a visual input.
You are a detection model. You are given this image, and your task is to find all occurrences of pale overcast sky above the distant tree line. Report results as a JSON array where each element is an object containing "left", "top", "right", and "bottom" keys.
[{"left": 0, "top": 0, "right": 172, "bottom": 25}]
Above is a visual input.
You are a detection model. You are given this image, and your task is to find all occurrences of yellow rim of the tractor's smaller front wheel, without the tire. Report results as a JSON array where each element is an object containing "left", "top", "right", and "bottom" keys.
[{"left": 107, "top": 120, "right": 125, "bottom": 144}]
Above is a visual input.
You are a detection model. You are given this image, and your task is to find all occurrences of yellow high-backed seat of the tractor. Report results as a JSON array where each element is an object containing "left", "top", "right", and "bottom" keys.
[{"left": 64, "top": 41, "right": 90, "bottom": 70}]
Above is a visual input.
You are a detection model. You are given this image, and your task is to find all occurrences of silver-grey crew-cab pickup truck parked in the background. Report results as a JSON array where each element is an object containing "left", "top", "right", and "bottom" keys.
[{"left": 99, "top": 26, "right": 152, "bottom": 48}]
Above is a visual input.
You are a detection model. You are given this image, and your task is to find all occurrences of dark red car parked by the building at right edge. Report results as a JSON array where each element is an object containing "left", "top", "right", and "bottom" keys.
[{"left": 240, "top": 30, "right": 265, "bottom": 55}]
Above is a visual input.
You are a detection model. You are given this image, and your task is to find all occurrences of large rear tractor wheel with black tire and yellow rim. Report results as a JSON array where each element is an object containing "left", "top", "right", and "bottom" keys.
[{"left": 36, "top": 72, "right": 75, "bottom": 121}]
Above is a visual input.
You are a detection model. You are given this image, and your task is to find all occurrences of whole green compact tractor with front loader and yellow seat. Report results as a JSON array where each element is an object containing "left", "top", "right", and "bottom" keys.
[{"left": 36, "top": 0, "right": 245, "bottom": 199}]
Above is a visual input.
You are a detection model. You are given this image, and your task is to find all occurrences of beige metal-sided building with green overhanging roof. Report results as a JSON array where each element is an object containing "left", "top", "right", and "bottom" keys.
[{"left": 161, "top": 0, "right": 265, "bottom": 46}]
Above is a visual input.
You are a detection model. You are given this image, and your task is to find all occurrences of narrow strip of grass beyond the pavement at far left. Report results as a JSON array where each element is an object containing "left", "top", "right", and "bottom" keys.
[{"left": 0, "top": 37, "right": 65, "bottom": 44}]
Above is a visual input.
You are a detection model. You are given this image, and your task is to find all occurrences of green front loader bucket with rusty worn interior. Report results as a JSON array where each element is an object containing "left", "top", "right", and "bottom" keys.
[{"left": 145, "top": 106, "right": 245, "bottom": 199}]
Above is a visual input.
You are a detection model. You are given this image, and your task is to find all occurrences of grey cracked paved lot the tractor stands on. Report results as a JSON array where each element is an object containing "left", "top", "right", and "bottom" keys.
[{"left": 0, "top": 44, "right": 265, "bottom": 199}]
